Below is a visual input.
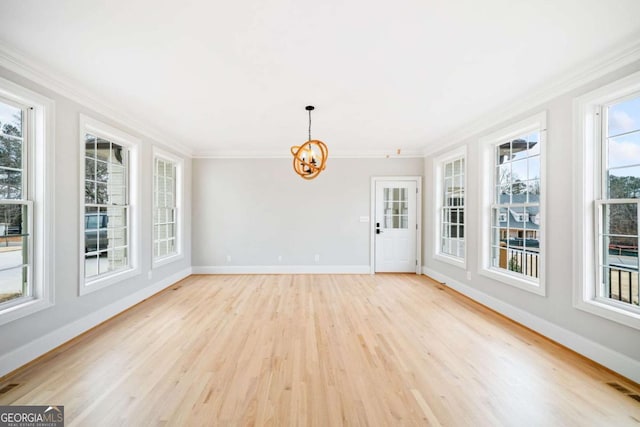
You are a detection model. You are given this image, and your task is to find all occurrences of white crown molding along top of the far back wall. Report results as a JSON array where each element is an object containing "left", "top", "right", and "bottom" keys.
[{"left": 193, "top": 150, "right": 424, "bottom": 159}]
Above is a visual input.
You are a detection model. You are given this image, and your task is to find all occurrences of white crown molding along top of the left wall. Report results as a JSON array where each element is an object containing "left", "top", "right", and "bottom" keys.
[{"left": 0, "top": 42, "right": 193, "bottom": 157}]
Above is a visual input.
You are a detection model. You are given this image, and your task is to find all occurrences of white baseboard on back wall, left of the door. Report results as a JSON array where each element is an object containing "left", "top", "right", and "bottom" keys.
[{"left": 193, "top": 265, "right": 371, "bottom": 274}]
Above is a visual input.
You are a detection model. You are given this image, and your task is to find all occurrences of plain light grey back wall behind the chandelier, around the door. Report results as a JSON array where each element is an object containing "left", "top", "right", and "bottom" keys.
[{"left": 192, "top": 155, "right": 424, "bottom": 272}]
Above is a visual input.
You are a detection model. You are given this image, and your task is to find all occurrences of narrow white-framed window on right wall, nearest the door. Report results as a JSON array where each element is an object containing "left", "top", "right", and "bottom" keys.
[{"left": 434, "top": 147, "right": 466, "bottom": 267}]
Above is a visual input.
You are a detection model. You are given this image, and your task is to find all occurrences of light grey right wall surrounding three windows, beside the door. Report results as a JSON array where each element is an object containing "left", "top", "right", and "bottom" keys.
[{"left": 423, "top": 59, "right": 640, "bottom": 381}]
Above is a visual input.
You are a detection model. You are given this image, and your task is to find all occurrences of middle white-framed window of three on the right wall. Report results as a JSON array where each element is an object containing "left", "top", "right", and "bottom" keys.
[{"left": 480, "top": 113, "right": 546, "bottom": 295}]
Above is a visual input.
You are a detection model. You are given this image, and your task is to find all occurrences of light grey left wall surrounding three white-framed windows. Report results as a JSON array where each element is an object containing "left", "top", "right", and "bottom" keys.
[{"left": 0, "top": 67, "right": 191, "bottom": 376}]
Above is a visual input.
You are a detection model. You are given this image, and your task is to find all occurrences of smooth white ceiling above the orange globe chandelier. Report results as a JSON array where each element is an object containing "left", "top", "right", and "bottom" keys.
[{"left": 0, "top": 0, "right": 640, "bottom": 156}]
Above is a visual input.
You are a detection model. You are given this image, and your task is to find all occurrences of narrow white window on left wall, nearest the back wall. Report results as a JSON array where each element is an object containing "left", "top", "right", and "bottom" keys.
[{"left": 153, "top": 149, "right": 182, "bottom": 265}]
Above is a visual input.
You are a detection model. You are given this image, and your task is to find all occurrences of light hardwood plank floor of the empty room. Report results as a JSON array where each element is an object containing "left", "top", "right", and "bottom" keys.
[{"left": 0, "top": 274, "right": 640, "bottom": 426}]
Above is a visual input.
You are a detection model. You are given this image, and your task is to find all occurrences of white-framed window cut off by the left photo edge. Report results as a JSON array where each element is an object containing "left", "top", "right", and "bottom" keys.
[{"left": 0, "top": 79, "right": 53, "bottom": 324}]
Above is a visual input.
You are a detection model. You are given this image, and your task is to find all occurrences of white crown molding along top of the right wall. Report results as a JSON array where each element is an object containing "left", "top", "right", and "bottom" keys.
[{"left": 422, "top": 34, "right": 640, "bottom": 157}]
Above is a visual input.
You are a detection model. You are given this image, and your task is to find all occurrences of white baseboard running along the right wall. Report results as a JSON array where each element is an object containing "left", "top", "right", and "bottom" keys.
[{"left": 422, "top": 266, "right": 640, "bottom": 383}]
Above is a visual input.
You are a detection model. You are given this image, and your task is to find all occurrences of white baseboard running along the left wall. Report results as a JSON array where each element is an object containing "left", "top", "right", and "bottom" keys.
[{"left": 0, "top": 268, "right": 191, "bottom": 377}]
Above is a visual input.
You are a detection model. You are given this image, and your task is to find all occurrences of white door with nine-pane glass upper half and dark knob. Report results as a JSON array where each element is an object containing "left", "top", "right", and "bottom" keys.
[{"left": 374, "top": 180, "right": 418, "bottom": 273}]
